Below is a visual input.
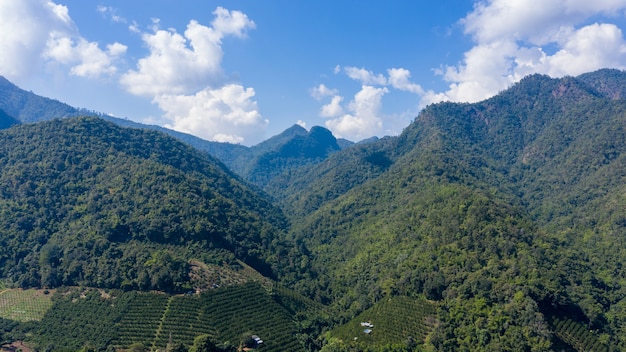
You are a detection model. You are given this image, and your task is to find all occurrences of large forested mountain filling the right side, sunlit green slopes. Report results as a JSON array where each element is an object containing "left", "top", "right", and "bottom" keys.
[{"left": 272, "top": 70, "right": 626, "bottom": 350}]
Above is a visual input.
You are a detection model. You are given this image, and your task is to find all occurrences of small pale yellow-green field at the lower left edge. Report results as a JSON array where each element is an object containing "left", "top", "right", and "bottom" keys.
[{"left": 0, "top": 289, "right": 52, "bottom": 322}]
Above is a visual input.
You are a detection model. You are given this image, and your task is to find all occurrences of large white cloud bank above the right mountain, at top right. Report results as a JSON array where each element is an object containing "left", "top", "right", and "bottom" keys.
[{"left": 440, "top": 0, "right": 626, "bottom": 102}]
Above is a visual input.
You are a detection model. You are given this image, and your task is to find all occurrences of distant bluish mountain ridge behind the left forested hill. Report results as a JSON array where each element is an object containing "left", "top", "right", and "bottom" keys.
[{"left": 0, "top": 76, "right": 353, "bottom": 185}]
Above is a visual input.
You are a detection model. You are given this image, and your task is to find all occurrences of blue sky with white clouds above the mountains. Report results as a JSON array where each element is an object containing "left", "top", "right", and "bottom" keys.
[{"left": 0, "top": 0, "right": 626, "bottom": 145}]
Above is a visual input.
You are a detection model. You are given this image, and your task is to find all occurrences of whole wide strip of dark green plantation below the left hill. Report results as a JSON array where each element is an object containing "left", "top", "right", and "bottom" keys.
[{"left": 0, "top": 283, "right": 304, "bottom": 351}]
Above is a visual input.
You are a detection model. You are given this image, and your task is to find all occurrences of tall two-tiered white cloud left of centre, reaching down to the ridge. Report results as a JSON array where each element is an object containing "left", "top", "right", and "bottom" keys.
[{"left": 120, "top": 7, "right": 260, "bottom": 143}]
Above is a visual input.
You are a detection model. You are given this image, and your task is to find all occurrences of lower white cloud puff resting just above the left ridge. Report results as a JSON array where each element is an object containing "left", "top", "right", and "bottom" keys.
[{"left": 155, "top": 84, "right": 268, "bottom": 143}]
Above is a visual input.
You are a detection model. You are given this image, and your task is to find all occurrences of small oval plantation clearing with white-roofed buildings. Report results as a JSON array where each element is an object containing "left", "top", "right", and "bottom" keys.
[{"left": 329, "top": 296, "right": 437, "bottom": 350}]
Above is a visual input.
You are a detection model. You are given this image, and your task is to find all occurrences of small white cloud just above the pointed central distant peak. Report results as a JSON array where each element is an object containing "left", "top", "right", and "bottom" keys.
[{"left": 326, "top": 85, "right": 389, "bottom": 141}]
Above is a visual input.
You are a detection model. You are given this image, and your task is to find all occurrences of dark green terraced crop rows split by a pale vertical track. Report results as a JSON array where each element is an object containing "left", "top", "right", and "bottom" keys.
[{"left": 114, "top": 283, "right": 303, "bottom": 351}]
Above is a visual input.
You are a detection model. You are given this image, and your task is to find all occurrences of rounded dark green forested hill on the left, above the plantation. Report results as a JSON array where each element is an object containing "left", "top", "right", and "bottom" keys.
[{"left": 0, "top": 117, "right": 286, "bottom": 292}]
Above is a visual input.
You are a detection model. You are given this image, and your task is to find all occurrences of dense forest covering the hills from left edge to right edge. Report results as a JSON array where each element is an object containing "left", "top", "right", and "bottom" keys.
[{"left": 0, "top": 70, "right": 626, "bottom": 351}]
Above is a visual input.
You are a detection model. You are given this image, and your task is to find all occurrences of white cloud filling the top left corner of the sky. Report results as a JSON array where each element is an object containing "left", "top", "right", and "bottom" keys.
[{"left": 0, "top": 0, "right": 125, "bottom": 83}]
